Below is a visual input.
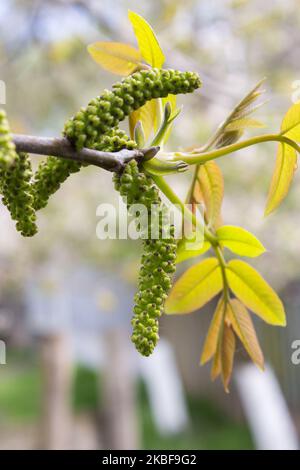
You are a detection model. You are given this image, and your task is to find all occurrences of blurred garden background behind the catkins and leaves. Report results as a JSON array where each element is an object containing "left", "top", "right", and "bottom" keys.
[{"left": 0, "top": 0, "right": 300, "bottom": 449}]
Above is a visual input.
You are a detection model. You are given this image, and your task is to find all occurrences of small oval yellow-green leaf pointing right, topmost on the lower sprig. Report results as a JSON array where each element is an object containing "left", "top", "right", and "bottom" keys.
[{"left": 217, "top": 225, "right": 265, "bottom": 258}]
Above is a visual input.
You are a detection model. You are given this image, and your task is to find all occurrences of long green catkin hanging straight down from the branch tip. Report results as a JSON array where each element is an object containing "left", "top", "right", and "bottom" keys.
[{"left": 114, "top": 160, "right": 176, "bottom": 356}]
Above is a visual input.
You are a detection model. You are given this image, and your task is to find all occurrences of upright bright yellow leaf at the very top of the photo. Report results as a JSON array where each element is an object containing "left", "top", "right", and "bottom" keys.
[{"left": 128, "top": 10, "right": 165, "bottom": 68}]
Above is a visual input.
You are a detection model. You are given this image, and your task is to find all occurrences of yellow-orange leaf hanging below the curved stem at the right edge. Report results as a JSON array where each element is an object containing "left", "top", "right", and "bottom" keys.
[{"left": 265, "top": 143, "right": 297, "bottom": 216}]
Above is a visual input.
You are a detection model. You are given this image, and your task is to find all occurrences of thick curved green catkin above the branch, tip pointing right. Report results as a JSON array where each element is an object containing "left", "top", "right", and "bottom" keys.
[{"left": 64, "top": 69, "right": 201, "bottom": 149}]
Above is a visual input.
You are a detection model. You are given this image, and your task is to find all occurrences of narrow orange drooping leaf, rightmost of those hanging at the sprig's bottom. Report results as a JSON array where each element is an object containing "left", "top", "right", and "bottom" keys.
[{"left": 226, "top": 299, "right": 264, "bottom": 370}]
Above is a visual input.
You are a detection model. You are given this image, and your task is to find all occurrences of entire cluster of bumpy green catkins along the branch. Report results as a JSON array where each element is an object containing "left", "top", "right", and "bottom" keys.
[{"left": 0, "top": 69, "right": 201, "bottom": 356}]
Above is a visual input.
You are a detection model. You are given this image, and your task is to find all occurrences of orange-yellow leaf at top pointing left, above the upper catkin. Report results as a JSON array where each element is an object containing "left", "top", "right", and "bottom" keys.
[{"left": 87, "top": 41, "right": 142, "bottom": 75}]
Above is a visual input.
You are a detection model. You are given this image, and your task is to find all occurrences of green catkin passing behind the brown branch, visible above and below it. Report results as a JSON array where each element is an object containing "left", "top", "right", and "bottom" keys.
[{"left": 32, "top": 129, "right": 136, "bottom": 210}]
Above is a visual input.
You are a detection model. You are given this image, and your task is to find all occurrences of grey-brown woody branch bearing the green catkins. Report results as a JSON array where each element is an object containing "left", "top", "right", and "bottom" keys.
[{"left": 12, "top": 134, "right": 159, "bottom": 171}]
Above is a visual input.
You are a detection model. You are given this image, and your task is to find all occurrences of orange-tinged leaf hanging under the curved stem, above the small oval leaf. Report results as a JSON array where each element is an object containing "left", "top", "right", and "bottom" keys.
[{"left": 188, "top": 161, "right": 224, "bottom": 228}]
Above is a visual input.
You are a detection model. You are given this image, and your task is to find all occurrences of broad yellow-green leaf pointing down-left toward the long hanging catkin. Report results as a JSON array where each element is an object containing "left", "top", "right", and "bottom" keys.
[{"left": 165, "top": 258, "right": 223, "bottom": 314}]
